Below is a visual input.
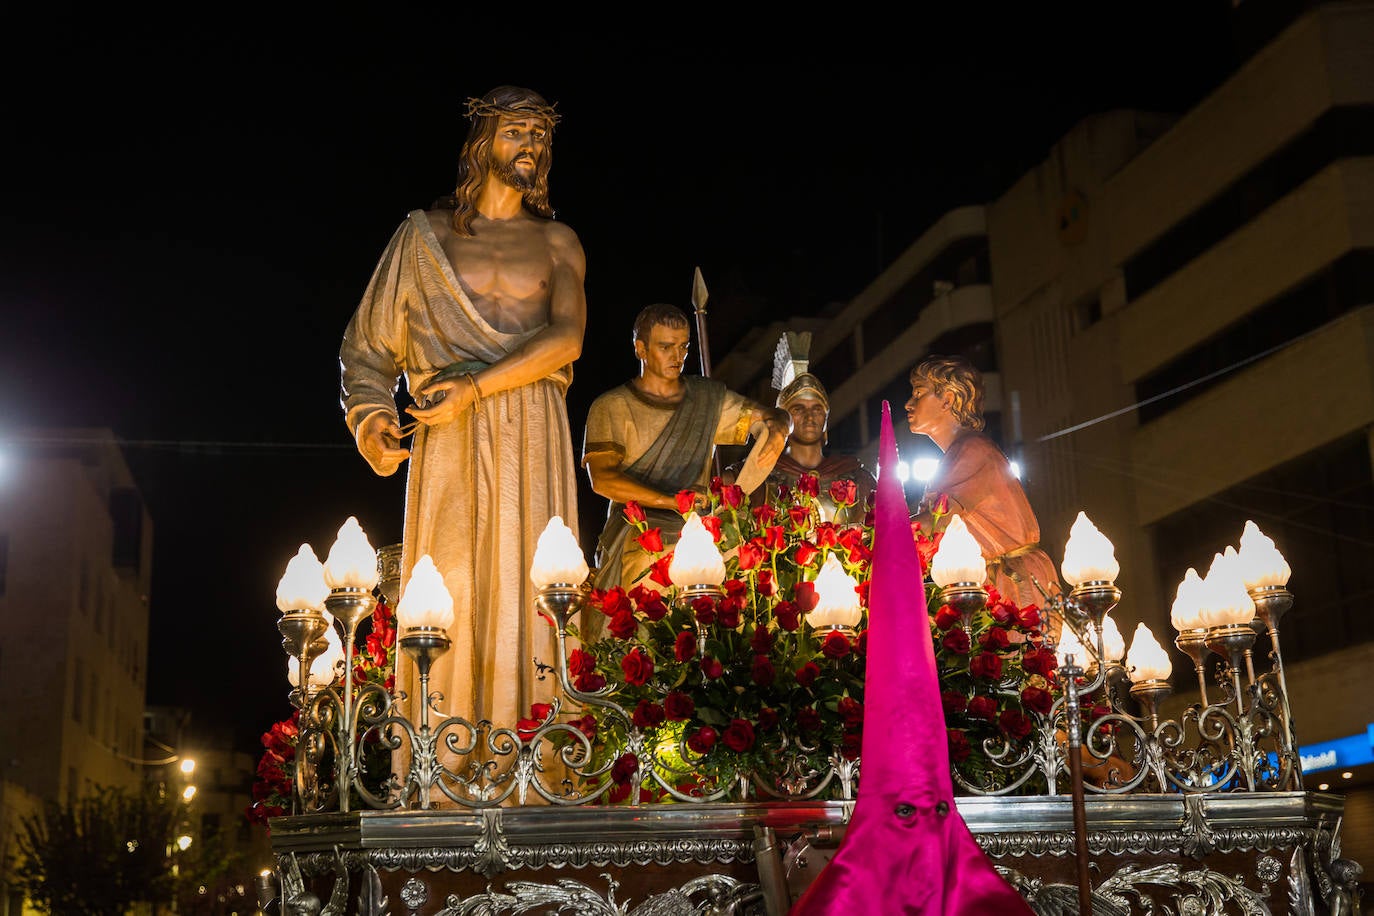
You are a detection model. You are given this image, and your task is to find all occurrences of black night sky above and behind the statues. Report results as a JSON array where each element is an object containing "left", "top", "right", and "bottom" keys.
[{"left": 0, "top": 8, "right": 1237, "bottom": 750}]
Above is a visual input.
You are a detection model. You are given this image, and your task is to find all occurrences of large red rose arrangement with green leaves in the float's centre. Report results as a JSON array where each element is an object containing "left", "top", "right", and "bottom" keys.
[{"left": 552, "top": 474, "right": 1055, "bottom": 801}]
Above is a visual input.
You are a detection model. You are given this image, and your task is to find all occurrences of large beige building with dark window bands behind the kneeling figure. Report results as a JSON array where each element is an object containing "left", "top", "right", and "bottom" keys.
[{"left": 714, "top": 3, "right": 1374, "bottom": 878}]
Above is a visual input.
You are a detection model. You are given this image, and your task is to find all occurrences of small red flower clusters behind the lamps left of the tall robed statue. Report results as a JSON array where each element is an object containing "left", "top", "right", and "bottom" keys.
[{"left": 243, "top": 599, "right": 396, "bottom": 827}]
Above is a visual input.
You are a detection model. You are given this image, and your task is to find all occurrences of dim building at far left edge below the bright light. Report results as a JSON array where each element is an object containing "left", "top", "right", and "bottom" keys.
[{"left": 0, "top": 430, "right": 153, "bottom": 912}]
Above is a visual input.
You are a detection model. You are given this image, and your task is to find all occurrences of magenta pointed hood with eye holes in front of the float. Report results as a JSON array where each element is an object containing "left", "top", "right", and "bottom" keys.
[{"left": 790, "top": 401, "right": 1032, "bottom": 916}]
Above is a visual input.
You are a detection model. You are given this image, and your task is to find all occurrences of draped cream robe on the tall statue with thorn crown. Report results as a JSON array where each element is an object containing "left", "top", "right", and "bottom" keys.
[{"left": 339, "top": 210, "right": 577, "bottom": 785}]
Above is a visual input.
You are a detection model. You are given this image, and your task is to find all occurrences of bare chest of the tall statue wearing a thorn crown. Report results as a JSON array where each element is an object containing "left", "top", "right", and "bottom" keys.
[{"left": 433, "top": 216, "right": 554, "bottom": 334}]
